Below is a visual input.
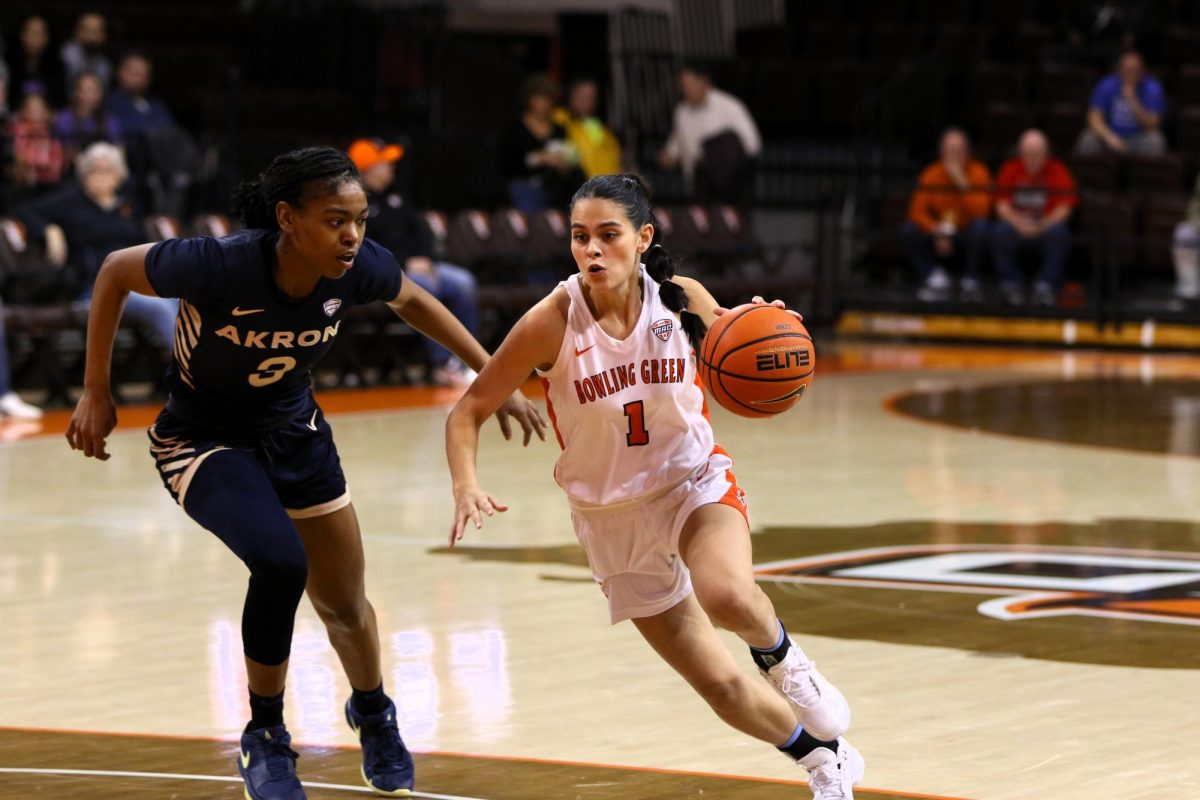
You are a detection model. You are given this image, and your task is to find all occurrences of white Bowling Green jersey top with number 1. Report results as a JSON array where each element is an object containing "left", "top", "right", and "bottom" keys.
[{"left": 539, "top": 267, "right": 713, "bottom": 505}]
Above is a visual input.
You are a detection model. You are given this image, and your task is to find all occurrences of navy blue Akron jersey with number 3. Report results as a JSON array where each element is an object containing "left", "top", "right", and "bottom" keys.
[{"left": 145, "top": 229, "right": 402, "bottom": 432}]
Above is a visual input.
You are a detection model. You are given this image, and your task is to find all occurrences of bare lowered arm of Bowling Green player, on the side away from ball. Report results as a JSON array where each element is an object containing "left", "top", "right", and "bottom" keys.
[{"left": 446, "top": 291, "right": 566, "bottom": 547}]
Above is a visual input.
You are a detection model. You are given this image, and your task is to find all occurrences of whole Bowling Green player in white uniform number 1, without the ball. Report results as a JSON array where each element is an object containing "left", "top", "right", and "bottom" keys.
[{"left": 446, "top": 175, "right": 863, "bottom": 800}]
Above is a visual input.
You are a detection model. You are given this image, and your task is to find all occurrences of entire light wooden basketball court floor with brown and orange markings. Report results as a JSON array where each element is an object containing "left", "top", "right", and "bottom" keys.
[{"left": 0, "top": 344, "right": 1200, "bottom": 800}]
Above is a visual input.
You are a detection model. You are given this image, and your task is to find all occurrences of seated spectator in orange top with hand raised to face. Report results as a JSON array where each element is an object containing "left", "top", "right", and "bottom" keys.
[{"left": 900, "top": 128, "right": 991, "bottom": 302}]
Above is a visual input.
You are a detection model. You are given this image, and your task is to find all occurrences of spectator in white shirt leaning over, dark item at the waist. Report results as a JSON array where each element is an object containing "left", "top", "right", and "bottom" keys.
[{"left": 659, "top": 64, "right": 762, "bottom": 204}]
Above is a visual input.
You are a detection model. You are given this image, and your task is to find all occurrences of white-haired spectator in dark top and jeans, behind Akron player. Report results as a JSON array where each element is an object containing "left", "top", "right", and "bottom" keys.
[{"left": 17, "top": 142, "right": 178, "bottom": 356}]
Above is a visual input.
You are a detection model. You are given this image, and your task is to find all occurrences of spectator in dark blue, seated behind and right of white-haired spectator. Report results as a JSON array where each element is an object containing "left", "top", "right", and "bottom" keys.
[{"left": 108, "top": 52, "right": 199, "bottom": 218}]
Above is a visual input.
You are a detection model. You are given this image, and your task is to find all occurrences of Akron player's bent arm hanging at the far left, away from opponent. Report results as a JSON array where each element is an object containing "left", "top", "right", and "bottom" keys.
[{"left": 67, "top": 245, "right": 157, "bottom": 461}]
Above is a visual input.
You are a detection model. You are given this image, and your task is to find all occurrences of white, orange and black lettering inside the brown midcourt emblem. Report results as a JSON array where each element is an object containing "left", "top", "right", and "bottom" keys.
[{"left": 755, "top": 545, "right": 1200, "bottom": 626}]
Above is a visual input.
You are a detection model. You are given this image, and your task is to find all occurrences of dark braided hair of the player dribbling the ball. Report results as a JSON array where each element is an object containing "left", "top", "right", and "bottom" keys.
[{"left": 571, "top": 173, "right": 707, "bottom": 351}]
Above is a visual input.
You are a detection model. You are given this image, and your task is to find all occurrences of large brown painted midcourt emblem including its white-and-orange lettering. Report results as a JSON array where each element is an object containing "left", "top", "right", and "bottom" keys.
[{"left": 439, "top": 518, "right": 1200, "bottom": 669}]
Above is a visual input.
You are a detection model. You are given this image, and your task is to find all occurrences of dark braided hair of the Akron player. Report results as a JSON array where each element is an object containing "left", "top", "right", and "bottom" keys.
[{"left": 233, "top": 148, "right": 362, "bottom": 230}]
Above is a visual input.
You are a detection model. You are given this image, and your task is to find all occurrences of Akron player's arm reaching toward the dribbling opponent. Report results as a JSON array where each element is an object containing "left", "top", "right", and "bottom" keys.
[{"left": 388, "top": 281, "right": 546, "bottom": 445}]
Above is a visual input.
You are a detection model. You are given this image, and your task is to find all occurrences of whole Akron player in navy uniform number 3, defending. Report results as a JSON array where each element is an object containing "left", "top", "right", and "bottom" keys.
[{"left": 67, "top": 148, "right": 545, "bottom": 800}]
